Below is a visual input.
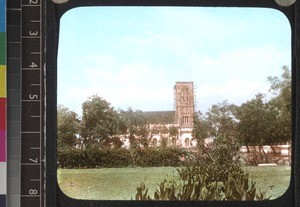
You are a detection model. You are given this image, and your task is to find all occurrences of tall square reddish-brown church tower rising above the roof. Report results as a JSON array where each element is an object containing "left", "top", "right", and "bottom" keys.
[{"left": 174, "top": 82, "right": 195, "bottom": 128}]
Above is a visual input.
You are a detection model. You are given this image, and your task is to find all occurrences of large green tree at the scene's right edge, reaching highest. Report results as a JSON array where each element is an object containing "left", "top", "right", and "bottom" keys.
[{"left": 236, "top": 66, "right": 292, "bottom": 152}]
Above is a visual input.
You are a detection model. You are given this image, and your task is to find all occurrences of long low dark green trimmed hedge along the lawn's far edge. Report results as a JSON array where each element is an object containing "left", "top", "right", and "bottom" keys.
[{"left": 57, "top": 148, "right": 187, "bottom": 168}]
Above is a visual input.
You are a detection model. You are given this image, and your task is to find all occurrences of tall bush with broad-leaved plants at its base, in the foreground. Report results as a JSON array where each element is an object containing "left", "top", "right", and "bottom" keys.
[{"left": 136, "top": 135, "right": 269, "bottom": 200}]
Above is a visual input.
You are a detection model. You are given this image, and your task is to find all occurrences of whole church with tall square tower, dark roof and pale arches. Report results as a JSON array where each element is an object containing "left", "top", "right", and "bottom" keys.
[{"left": 122, "top": 82, "right": 197, "bottom": 148}]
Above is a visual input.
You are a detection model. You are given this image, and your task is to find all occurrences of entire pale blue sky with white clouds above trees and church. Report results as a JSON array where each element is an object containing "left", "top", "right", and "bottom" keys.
[{"left": 57, "top": 7, "right": 291, "bottom": 115}]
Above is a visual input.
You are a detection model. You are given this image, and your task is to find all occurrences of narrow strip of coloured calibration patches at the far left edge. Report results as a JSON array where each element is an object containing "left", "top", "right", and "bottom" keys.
[{"left": 0, "top": 0, "right": 7, "bottom": 207}]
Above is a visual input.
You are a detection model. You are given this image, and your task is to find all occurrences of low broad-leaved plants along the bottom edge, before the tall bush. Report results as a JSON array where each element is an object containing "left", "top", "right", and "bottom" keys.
[{"left": 135, "top": 171, "right": 269, "bottom": 201}]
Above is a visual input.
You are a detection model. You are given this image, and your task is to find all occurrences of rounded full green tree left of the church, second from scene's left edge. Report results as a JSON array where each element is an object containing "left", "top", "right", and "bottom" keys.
[{"left": 81, "top": 95, "right": 119, "bottom": 147}]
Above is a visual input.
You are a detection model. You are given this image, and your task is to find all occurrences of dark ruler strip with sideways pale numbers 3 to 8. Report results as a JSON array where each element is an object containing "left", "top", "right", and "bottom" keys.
[{"left": 21, "top": 0, "right": 45, "bottom": 207}]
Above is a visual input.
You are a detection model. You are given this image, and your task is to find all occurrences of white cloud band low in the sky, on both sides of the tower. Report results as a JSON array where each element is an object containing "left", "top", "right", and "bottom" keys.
[{"left": 59, "top": 44, "right": 289, "bottom": 115}]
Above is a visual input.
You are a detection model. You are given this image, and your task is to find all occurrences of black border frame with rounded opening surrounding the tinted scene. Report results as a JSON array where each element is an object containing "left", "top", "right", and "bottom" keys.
[{"left": 43, "top": 0, "right": 300, "bottom": 207}]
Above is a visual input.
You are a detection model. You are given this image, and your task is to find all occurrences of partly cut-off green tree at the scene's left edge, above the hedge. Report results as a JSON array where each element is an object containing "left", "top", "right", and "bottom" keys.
[{"left": 57, "top": 105, "right": 80, "bottom": 150}]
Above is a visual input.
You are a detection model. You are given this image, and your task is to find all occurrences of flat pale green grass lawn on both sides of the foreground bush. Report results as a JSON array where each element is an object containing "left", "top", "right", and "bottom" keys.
[{"left": 57, "top": 166, "right": 290, "bottom": 200}]
